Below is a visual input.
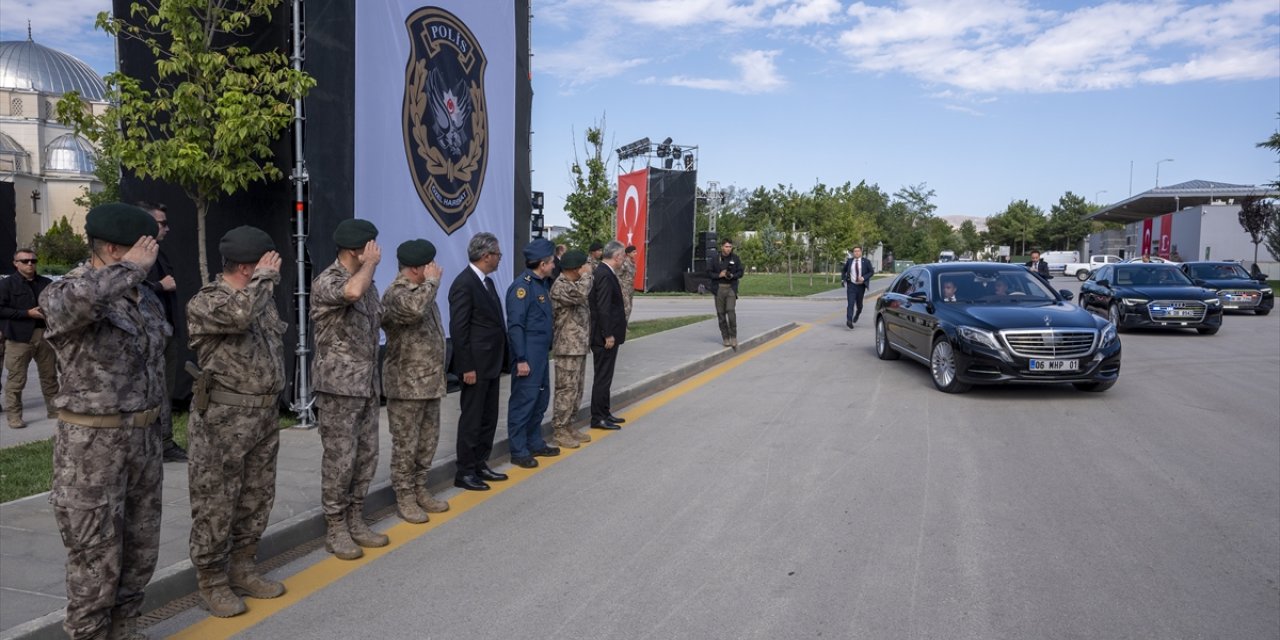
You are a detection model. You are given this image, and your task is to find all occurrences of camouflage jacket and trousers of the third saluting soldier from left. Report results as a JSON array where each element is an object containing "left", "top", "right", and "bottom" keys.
[{"left": 311, "top": 260, "right": 383, "bottom": 517}]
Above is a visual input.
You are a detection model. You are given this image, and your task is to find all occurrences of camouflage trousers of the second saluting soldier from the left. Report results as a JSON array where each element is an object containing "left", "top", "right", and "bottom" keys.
[{"left": 187, "top": 403, "right": 280, "bottom": 571}]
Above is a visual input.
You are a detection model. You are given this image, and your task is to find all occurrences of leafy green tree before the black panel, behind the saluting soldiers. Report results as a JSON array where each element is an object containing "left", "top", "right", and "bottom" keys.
[{"left": 58, "top": 0, "right": 315, "bottom": 282}]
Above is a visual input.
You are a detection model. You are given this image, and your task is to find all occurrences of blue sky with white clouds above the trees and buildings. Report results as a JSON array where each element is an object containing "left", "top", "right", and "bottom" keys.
[{"left": 0, "top": 0, "right": 1280, "bottom": 224}]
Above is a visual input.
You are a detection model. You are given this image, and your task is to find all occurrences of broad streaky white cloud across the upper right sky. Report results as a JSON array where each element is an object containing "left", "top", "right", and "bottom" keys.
[{"left": 840, "top": 0, "right": 1280, "bottom": 93}]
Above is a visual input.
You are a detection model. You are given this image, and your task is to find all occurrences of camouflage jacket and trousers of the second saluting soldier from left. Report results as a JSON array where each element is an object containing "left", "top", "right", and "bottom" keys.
[{"left": 187, "top": 270, "right": 285, "bottom": 571}]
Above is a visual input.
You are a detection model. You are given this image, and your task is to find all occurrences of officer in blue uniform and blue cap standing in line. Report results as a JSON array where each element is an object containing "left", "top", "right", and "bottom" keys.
[{"left": 507, "top": 239, "right": 559, "bottom": 468}]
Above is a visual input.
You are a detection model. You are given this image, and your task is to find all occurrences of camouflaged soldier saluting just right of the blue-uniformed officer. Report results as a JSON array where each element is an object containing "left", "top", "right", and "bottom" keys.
[{"left": 552, "top": 250, "right": 591, "bottom": 449}]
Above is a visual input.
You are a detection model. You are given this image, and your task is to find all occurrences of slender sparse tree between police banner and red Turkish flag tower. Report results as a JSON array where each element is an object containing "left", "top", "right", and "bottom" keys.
[{"left": 564, "top": 118, "right": 614, "bottom": 250}]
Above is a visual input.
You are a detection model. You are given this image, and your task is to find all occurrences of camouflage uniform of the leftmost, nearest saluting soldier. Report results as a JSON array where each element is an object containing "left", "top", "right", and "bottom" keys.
[{"left": 40, "top": 262, "right": 173, "bottom": 639}]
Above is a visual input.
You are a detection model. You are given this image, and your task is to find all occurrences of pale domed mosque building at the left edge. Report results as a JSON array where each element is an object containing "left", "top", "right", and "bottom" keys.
[{"left": 0, "top": 33, "right": 108, "bottom": 247}]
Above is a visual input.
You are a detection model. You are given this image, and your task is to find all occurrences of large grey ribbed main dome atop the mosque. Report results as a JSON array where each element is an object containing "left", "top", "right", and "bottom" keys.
[{"left": 0, "top": 40, "right": 106, "bottom": 102}]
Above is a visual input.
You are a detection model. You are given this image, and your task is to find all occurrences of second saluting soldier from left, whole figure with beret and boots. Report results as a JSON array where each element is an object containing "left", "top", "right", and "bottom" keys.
[{"left": 187, "top": 227, "right": 285, "bottom": 618}]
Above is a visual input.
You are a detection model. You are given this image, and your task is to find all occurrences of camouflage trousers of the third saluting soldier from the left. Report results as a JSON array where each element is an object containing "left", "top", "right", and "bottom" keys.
[{"left": 316, "top": 393, "right": 378, "bottom": 517}]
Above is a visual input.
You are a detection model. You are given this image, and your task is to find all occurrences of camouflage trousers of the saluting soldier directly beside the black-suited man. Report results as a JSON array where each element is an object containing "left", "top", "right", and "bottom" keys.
[{"left": 387, "top": 398, "right": 440, "bottom": 495}]
